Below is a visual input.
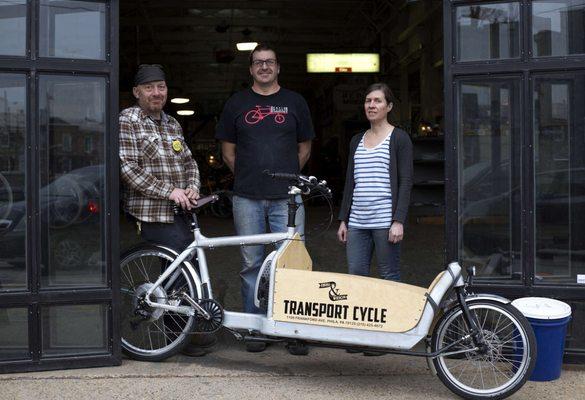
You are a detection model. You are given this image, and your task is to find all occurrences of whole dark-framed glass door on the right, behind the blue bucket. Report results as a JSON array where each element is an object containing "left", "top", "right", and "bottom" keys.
[{"left": 444, "top": 0, "right": 585, "bottom": 363}]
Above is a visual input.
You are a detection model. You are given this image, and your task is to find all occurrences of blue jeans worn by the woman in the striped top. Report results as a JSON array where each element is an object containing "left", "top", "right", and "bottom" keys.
[{"left": 346, "top": 228, "right": 400, "bottom": 281}]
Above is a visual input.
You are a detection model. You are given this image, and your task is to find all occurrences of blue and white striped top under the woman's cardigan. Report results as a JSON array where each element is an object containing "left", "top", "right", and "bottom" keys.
[{"left": 349, "top": 132, "right": 392, "bottom": 229}]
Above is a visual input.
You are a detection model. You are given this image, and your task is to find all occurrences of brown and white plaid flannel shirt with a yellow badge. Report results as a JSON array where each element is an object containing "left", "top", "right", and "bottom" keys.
[{"left": 119, "top": 106, "right": 200, "bottom": 223}]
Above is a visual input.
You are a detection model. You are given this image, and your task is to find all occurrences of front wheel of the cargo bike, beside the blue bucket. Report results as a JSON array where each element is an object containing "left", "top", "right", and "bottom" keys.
[{"left": 431, "top": 300, "right": 536, "bottom": 399}]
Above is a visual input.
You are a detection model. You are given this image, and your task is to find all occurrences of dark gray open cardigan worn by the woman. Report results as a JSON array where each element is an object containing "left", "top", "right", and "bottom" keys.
[{"left": 338, "top": 127, "right": 412, "bottom": 224}]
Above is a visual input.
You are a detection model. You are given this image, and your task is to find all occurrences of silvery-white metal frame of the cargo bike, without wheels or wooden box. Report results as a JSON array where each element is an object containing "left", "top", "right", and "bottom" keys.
[{"left": 145, "top": 187, "right": 472, "bottom": 350}]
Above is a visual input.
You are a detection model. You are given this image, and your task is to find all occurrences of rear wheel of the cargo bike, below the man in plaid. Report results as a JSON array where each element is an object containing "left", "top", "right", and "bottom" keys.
[{"left": 120, "top": 246, "right": 201, "bottom": 361}]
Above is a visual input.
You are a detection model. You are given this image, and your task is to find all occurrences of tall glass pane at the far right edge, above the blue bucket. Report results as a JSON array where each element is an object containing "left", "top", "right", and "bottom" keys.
[{"left": 532, "top": 72, "right": 585, "bottom": 285}]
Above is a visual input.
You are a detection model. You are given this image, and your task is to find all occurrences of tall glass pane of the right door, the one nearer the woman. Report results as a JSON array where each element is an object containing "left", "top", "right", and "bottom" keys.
[{"left": 457, "top": 77, "right": 522, "bottom": 282}]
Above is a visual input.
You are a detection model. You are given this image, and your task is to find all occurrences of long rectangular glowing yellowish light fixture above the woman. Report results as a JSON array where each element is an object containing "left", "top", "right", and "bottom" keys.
[{"left": 307, "top": 53, "right": 380, "bottom": 73}]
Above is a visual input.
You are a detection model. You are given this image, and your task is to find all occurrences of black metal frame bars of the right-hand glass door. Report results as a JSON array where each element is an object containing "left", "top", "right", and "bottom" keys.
[{"left": 443, "top": 0, "right": 585, "bottom": 363}]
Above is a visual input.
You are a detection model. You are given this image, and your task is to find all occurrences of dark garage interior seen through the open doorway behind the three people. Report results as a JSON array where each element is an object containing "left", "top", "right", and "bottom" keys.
[{"left": 119, "top": 0, "right": 445, "bottom": 308}]
